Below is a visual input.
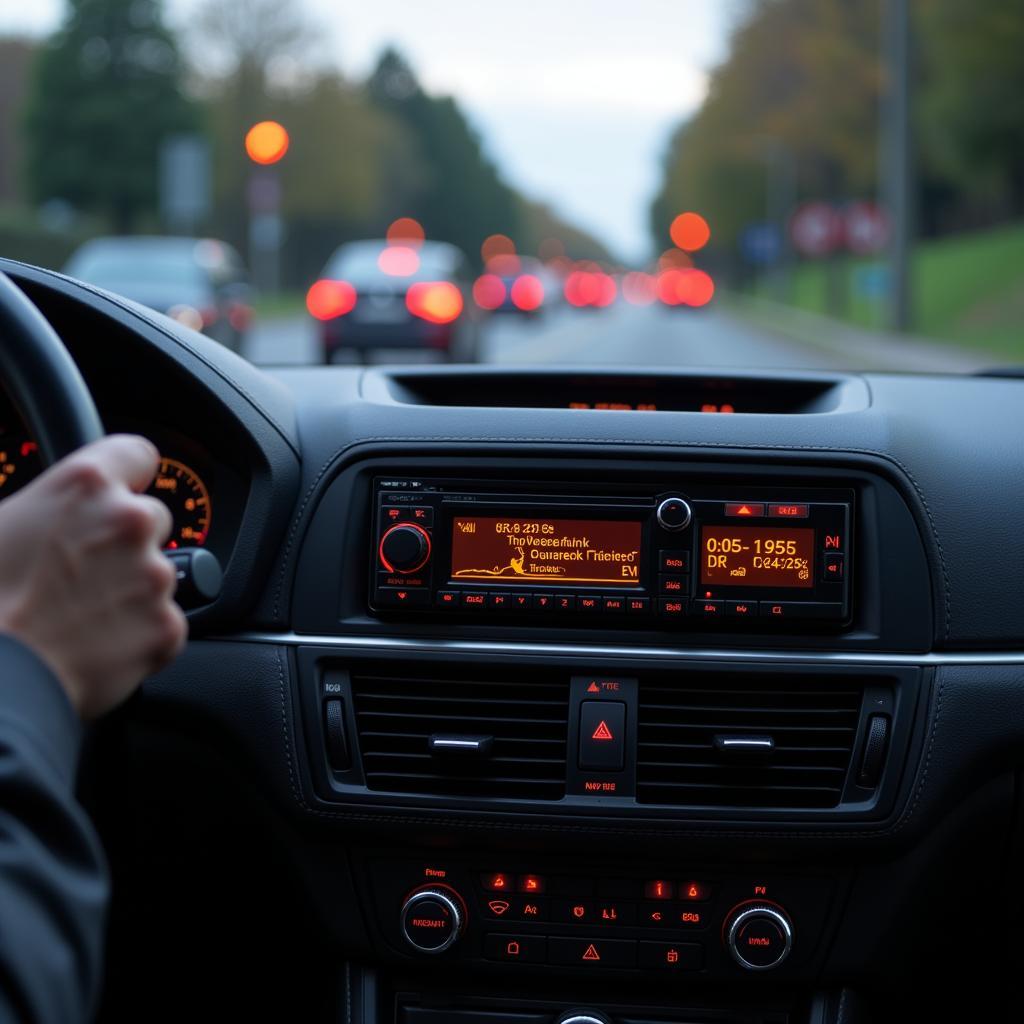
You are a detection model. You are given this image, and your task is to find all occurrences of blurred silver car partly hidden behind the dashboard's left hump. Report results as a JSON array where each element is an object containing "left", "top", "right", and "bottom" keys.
[{"left": 65, "top": 236, "right": 255, "bottom": 352}]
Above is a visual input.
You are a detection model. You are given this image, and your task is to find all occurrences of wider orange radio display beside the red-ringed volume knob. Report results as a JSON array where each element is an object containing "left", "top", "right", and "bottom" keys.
[{"left": 452, "top": 515, "right": 643, "bottom": 587}]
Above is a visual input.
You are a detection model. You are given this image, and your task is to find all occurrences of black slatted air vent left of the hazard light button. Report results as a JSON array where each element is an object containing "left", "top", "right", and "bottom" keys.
[{"left": 352, "top": 675, "right": 569, "bottom": 800}]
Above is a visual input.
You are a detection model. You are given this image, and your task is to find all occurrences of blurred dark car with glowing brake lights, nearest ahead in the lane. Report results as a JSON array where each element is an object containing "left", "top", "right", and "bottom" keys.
[{"left": 306, "top": 240, "right": 480, "bottom": 362}]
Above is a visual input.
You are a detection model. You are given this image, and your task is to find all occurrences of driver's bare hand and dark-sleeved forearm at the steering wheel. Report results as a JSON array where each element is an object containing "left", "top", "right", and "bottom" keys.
[{"left": 0, "top": 436, "right": 186, "bottom": 1024}]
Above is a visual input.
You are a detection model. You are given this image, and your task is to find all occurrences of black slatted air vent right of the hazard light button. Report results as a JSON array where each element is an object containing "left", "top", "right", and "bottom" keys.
[{"left": 637, "top": 675, "right": 862, "bottom": 809}]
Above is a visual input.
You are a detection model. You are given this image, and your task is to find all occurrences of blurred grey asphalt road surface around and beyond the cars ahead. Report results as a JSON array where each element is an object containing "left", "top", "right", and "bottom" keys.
[{"left": 243, "top": 303, "right": 972, "bottom": 373}]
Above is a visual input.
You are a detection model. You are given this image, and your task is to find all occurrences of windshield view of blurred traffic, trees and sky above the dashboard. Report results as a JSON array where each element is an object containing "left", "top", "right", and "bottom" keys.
[{"left": 0, "top": 0, "right": 1024, "bottom": 373}]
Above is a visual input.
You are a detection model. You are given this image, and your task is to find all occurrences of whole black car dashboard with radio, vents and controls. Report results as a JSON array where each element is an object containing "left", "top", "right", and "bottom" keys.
[{"left": 4, "top": 258, "right": 1024, "bottom": 1024}]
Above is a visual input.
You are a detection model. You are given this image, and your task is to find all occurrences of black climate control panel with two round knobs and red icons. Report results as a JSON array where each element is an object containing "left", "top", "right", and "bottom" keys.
[{"left": 365, "top": 860, "right": 835, "bottom": 976}]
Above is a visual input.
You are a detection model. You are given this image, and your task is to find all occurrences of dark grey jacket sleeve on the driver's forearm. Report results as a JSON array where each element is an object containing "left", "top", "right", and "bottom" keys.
[{"left": 0, "top": 636, "right": 110, "bottom": 1024}]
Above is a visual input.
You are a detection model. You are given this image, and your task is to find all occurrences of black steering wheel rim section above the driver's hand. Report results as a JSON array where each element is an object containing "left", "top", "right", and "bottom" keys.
[{"left": 0, "top": 271, "right": 103, "bottom": 466}]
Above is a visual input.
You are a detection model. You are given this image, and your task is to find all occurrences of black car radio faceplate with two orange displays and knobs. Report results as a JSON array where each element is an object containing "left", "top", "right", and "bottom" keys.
[{"left": 369, "top": 477, "right": 853, "bottom": 631}]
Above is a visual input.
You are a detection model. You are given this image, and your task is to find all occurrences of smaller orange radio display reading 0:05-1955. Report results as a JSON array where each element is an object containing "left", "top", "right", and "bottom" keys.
[{"left": 700, "top": 526, "right": 814, "bottom": 587}]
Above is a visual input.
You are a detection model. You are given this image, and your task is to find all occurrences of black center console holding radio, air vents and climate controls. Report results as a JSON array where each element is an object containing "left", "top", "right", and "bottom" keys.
[{"left": 280, "top": 450, "right": 933, "bottom": 1024}]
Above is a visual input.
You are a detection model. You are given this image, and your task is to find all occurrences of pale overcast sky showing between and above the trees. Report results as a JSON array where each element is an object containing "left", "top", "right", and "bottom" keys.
[{"left": 0, "top": 0, "right": 734, "bottom": 258}]
